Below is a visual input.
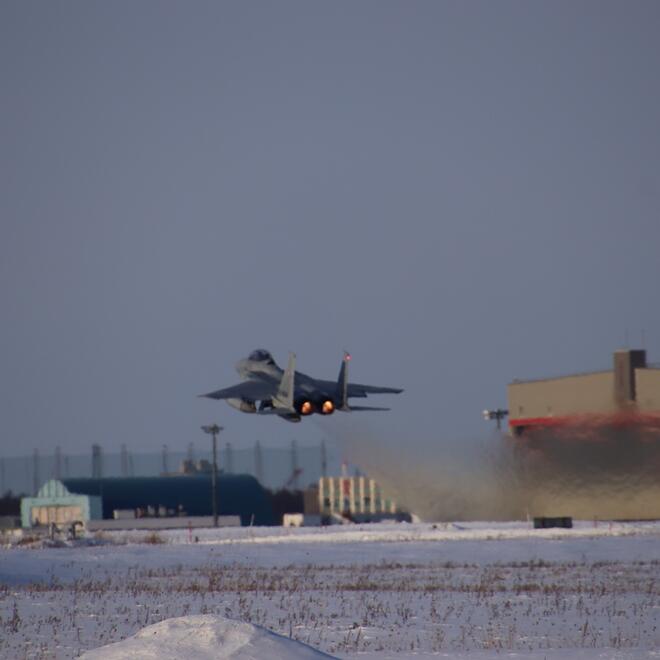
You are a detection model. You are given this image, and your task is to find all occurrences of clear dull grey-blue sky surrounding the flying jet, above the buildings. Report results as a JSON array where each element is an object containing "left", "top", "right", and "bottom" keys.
[{"left": 0, "top": 0, "right": 660, "bottom": 456}]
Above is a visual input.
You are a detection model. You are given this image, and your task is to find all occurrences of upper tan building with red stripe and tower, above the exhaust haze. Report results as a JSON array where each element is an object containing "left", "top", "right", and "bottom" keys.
[{"left": 508, "top": 350, "right": 660, "bottom": 436}]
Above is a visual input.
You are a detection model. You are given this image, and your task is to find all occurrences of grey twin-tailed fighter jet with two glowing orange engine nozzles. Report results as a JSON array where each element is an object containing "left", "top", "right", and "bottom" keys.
[{"left": 200, "top": 348, "right": 403, "bottom": 422}]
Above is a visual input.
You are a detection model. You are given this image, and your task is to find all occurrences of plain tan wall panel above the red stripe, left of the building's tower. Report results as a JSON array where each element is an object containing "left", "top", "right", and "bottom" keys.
[{"left": 508, "top": 371, "right": 617, "bottom": 420}]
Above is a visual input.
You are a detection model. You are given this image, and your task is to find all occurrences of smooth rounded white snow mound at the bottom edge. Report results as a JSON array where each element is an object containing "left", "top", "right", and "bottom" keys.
[{"left": 80, "top": 614, "right": 332, "bottom": 660}]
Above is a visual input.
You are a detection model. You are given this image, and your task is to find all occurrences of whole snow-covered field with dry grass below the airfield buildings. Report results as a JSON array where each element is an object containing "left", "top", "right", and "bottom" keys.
[{"left": 0, "top": 522, "right": 660, "bottom": 660}]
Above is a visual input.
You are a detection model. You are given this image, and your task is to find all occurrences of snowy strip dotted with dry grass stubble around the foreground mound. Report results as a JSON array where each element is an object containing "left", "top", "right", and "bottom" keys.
[{"left": 0, "top": 556, "right": 660, "bottom": 657}]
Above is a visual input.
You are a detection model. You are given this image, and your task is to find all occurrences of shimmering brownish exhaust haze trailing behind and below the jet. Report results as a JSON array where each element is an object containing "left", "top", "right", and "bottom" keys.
[{"left": 324, "top": 423, "right": 660, "bottom": 521}]
